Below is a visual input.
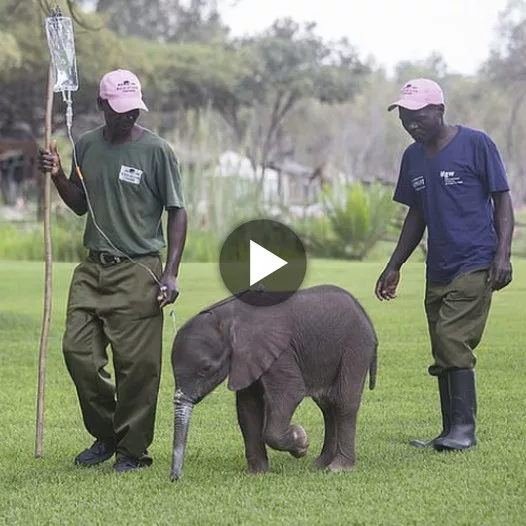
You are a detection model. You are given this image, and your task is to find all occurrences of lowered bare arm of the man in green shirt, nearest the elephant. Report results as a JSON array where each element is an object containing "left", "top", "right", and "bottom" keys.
[{"left": 160, "top": 208, "right": 188, "bottom": 308}]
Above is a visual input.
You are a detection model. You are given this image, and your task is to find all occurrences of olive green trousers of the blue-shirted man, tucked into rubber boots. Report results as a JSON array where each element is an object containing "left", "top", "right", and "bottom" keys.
[{"left": 424, "top": 269, "right": 492, "bottom": 376}]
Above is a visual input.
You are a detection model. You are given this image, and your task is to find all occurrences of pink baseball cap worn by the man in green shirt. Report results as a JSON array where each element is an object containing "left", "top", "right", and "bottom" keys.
[{"left": 99, "top": 69, "right": 148, "bottom": 113}]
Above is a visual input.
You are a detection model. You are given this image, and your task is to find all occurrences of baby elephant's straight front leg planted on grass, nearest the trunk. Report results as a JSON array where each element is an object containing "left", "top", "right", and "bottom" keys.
[{"left": 236, "top": 383, "right": 268, "bottom": 473}]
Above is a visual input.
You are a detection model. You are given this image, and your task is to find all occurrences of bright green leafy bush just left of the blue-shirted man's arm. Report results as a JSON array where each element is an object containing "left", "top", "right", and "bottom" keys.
[{"left": 298, "top": 182, "right": 398, "bottom": 260}]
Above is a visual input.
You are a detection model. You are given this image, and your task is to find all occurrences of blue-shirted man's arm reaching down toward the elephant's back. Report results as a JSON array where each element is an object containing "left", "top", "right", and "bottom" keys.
[{"left": 376, "top": 208, "right": 426, "bottom": 300}]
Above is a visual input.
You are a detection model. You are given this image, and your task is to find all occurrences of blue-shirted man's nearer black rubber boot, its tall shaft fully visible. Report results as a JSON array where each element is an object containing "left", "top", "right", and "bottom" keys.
[{"left": 434, "top": 369, "right": 477, "bottom": 451}]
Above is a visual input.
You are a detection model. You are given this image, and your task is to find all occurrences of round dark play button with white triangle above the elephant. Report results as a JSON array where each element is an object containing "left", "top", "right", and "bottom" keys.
[{"left": 219, "top": 219, "right": 307, "bottom": 306}]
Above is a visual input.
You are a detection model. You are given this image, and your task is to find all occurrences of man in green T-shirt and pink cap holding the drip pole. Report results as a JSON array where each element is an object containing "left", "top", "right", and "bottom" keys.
[{"left": 39, "top": 70, "right": 187, "bottom": 473}]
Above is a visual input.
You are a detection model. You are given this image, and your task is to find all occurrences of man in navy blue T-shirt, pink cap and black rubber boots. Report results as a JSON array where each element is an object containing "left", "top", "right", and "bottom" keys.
[{"left": 376, "top": 79, "right": 514, "bottom": 451}]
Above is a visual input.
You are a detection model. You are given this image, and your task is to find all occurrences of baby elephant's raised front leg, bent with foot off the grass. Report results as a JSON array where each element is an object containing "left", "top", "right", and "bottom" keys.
[{"left": 260, "top": 369, "right": 309, "bottom": 458}]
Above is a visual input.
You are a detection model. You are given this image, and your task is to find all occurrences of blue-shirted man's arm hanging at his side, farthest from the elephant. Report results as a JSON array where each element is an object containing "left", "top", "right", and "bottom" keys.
[{"left": 489, "top": 192, "right": 515, "bottom": 290}]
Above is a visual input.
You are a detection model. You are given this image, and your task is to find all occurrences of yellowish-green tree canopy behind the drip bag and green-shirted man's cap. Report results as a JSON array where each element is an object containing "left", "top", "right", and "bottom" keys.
[{"left": 0, "top": 0, "right": 252, "bottom": 136}]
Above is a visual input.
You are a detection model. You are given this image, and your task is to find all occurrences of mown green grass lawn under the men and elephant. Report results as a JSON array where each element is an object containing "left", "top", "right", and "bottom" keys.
[{"left": 0, "top": 260, "right": 526, "bottom": 525}]
